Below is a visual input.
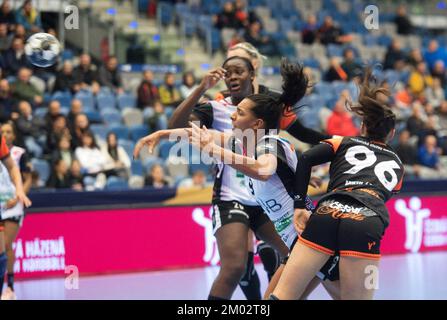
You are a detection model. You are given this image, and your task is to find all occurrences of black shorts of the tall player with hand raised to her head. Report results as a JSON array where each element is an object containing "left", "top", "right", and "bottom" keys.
[{"left": 213, "top": 201, "right": 270, "bottom": 233}]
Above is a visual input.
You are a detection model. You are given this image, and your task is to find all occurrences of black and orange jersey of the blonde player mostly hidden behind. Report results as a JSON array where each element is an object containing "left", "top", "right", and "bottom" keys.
[{"left": 216, "top": 85, "right": 331, "bottom": 145}]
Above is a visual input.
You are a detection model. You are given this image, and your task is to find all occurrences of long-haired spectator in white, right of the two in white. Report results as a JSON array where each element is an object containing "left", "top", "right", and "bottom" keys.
[{"left": 102, "top": 132, "right": 130, "bottom": 178}]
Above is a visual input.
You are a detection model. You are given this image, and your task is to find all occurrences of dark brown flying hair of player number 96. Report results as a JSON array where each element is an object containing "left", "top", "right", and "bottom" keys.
[{"left": 346, "top": 68, "right": 396, "bottom": 141}]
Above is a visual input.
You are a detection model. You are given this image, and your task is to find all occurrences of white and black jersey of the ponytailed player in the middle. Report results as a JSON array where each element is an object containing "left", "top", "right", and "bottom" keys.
[{"left": 246, "top": 135, "right": 312, "bottom": 248}]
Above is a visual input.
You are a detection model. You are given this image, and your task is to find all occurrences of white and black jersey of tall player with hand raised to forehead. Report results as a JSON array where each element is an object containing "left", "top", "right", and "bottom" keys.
[{"left": 193, "top": 97, "right": 258, "bottom": 206}]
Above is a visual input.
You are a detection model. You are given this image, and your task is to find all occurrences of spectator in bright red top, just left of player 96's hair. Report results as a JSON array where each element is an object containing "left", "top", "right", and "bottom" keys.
[{"left": 326, "top": 90, "right": 359, "bottom": 137}]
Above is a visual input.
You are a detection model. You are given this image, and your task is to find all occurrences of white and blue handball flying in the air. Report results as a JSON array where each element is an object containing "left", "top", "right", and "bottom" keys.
[{"left": 25, "top": 32, "right": 61, "bottom": 68}]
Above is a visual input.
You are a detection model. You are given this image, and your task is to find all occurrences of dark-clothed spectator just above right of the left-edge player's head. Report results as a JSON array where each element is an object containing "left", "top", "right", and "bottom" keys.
[{"left": 16, "top": 101, "right": 45, "bottom": 141}]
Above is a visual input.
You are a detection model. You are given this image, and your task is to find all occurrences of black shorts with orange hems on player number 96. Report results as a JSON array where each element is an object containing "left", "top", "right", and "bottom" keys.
[{"left": 298, "top": 195, "right": 385, "bottom": 259}]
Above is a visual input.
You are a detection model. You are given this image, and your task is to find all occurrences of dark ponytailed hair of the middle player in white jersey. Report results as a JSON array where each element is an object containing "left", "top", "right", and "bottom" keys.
[{"left": 243, "top": 58, "right": 309, "bottom": 130}]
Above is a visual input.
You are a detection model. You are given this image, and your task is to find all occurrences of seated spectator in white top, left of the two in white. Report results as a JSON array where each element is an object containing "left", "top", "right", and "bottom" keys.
[{"left": 75, "top": 131, "right": 107, "bottom": 179}]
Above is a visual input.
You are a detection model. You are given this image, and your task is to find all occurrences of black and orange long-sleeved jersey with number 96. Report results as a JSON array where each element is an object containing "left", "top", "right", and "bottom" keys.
[{"left": 295, "top": 137, "right": 404, "bottom": 226}]
